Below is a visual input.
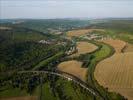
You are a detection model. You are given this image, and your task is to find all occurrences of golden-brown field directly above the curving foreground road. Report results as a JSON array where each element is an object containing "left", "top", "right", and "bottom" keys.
[{"left": 58, "top": 60, "right": 87, "bottom": 81}]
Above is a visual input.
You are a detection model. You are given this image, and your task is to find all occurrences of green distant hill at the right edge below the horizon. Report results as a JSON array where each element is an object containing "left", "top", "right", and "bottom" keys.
[{"left": 89, "top": 18, "right": 133, "bottom": 34}]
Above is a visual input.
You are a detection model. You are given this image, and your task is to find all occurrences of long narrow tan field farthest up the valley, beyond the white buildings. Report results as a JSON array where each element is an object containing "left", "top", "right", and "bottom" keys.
[{"left": 67, "top": 29, "right": 104, "bottom": 37}]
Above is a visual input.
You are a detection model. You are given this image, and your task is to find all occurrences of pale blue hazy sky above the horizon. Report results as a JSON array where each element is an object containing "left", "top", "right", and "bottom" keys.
[{"left": 0, "top": 0, "right": 133, "bottom": 19}]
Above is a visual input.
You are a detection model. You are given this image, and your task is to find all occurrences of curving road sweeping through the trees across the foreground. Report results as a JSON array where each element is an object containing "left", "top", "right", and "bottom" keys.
[{"left": 18, "top": 70, "right": 103, "bottom": 99}]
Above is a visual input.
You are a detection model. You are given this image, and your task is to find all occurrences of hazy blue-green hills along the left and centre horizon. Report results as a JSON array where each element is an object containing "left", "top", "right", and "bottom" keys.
[{"left": 1, "top": 19, "right": 89, "bottom": 33}]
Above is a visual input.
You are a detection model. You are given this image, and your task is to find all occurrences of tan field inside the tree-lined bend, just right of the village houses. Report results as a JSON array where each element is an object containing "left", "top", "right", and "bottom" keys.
[{"left": 71, "top": 42, "right": 97, "bottom": 56}]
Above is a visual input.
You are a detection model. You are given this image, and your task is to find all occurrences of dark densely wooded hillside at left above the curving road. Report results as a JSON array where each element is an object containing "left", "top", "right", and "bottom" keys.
[{"left": 0, "top": 26, "right": 71, "bottom": 71}]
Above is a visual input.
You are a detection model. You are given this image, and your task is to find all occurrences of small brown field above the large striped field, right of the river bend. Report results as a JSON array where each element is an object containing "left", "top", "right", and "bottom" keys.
[{"left": 102, "top": 39, "right": 126, "bottom": 53}]
